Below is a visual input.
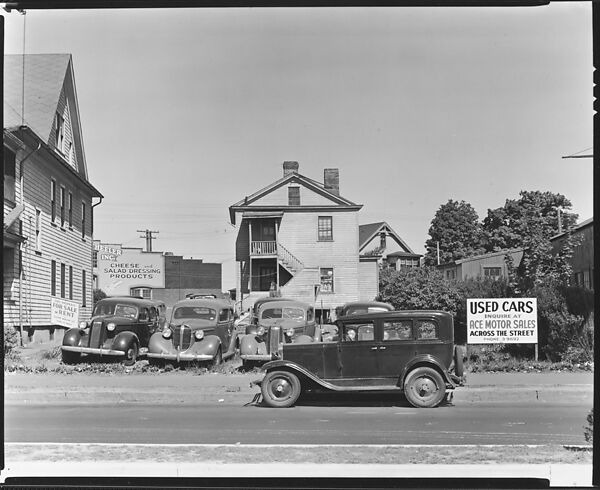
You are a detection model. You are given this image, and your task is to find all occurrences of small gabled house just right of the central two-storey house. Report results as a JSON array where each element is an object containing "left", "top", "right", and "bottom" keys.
[{"left": 358, "top": 221, "right": 421, "bottom": 270}]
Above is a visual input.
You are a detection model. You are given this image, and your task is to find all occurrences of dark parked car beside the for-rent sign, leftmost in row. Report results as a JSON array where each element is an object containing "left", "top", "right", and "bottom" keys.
[{"left": 61, "top": 296, "right": 164, "bottom": 366}]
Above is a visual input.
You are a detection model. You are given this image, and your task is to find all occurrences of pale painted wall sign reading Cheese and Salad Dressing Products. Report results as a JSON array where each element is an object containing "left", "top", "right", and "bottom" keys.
[{"left": 94, "top": 243, "right": 165, "bottom": 296}]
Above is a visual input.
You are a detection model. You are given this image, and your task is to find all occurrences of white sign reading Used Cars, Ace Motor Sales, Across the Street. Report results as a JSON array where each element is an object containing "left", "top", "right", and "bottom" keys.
[{"left": 467, "top": 298, "right": 537, "bottom": 344}]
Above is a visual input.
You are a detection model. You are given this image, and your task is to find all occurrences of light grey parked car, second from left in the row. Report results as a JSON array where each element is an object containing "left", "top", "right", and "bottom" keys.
[{"left": 148, "top": 298, "right": 236, "bottom": 364}]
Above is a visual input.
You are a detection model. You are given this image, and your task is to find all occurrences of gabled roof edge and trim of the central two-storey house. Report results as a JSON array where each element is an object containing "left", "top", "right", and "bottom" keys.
[{"left": 229, "top": 168, "right": 362, "bottom": 224}]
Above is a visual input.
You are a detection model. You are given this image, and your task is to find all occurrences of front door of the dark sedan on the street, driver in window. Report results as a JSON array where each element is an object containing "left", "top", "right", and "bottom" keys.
[{"left": 338, "top": 320, "right": 378, "bottom": 380}]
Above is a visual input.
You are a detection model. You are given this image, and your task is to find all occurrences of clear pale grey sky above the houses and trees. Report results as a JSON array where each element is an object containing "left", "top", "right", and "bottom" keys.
[{"left": 3, "top": 2, "right": 593, "bottom": 289}]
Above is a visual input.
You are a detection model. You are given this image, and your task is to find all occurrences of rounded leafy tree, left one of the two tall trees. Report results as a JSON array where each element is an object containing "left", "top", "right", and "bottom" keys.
[{"left": 424, "top": 199, "right": 485, "bottom": 265}]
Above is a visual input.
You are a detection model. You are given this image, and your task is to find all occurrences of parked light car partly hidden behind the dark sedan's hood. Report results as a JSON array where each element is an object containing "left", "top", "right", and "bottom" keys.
[{"left": 240, "top": 298, "right": 320, "bottom": 368}]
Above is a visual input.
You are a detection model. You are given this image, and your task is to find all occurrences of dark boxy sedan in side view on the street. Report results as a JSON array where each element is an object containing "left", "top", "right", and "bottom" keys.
[{"left": 255, "top": 310, "right": 464, "bottom": 407}]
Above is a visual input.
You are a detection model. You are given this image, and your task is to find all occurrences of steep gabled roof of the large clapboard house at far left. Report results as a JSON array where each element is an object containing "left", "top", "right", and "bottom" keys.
[{"left": 3, "top": 54, "right": 87, "bottom": 180}]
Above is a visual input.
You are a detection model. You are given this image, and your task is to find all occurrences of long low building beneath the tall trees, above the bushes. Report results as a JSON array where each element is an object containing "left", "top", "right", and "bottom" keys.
[{"left": 437, "top": 249, "right": 523, "bottom": 280}]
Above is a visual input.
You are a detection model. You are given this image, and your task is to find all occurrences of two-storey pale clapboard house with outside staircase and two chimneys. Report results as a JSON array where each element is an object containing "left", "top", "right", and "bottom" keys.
[{"left": 229, "top": 162, "right": 378, "bottom": 320}]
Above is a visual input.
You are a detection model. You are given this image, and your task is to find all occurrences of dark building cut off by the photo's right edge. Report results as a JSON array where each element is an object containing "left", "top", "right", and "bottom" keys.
[{"left": 550, "top": 218, "right": 594, "bottom": 289}]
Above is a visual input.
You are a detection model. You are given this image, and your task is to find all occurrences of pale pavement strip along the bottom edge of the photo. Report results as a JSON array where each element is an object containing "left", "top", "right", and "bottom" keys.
[{"left": 1, "top": 461, "right": 592, "bottom": 487}]
